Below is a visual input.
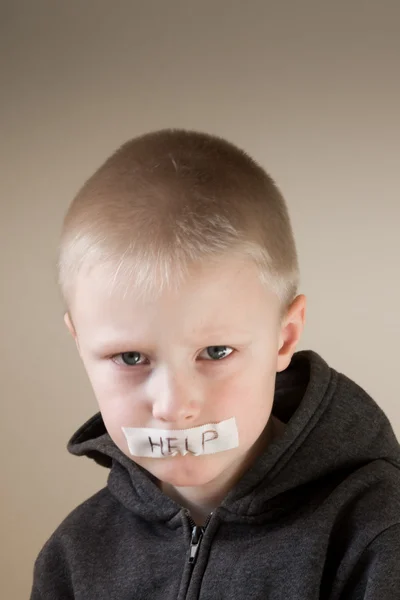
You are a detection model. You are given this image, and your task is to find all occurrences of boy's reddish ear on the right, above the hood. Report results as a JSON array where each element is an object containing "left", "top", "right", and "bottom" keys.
[{"left": 276, "top": 294, "right": 306, "bottom": 373}]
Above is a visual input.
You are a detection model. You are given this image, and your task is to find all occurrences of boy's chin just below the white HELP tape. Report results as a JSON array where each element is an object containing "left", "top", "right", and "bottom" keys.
[{"left": 135, "top": 450, "right": 233, "bottom": 487}]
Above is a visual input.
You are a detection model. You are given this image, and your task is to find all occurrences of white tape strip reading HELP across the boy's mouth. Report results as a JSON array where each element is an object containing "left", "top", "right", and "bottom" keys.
[{"left": 122, "top": 417, "right": 239, "bottom": 458}]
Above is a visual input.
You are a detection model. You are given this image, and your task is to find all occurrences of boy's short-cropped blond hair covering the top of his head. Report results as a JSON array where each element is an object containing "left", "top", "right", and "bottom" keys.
[{"left": 57, "top": 129, "right": 299, "bottom": 316}]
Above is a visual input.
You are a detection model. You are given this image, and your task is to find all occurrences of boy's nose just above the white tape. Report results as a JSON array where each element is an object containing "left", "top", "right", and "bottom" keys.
[{"left": 148, "top": 372, "right": 201, "bottom": 429}]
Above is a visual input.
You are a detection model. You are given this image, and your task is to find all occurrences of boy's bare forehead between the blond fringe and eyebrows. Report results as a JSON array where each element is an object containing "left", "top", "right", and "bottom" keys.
[{"left": 72, "top": 253, "right": 276, "bottom": 334}]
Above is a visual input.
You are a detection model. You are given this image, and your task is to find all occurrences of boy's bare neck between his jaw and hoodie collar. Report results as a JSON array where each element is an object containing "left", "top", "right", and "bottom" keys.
[{"left": 160, "top": 416, "right": 285, "bottom": 525}]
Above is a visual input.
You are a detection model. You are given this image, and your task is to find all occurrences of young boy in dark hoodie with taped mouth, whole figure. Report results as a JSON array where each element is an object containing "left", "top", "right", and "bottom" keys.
[{"left": 31, "top": 130, "right": 400, "bottom": 600}]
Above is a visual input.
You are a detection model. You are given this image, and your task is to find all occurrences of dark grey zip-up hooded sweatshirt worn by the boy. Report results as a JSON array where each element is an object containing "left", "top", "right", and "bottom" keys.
[{"left": 31, "top": 351, "right": 400, "bottom": 600}]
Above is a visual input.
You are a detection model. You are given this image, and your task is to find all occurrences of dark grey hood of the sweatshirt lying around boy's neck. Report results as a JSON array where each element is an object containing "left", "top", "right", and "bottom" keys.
[{"left": 68, "top": 350, "right": 400, "bottom": 522}]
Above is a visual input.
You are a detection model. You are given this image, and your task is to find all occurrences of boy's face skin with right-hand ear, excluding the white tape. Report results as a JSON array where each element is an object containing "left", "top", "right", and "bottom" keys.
[{"left": 65, "top": 258, "right": 304, "bottom": 487}]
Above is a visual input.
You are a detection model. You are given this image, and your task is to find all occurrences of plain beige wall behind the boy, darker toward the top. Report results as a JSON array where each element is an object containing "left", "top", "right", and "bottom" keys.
[{"left": 0, "top": 0, "right": 400, "bottom": 599}]
